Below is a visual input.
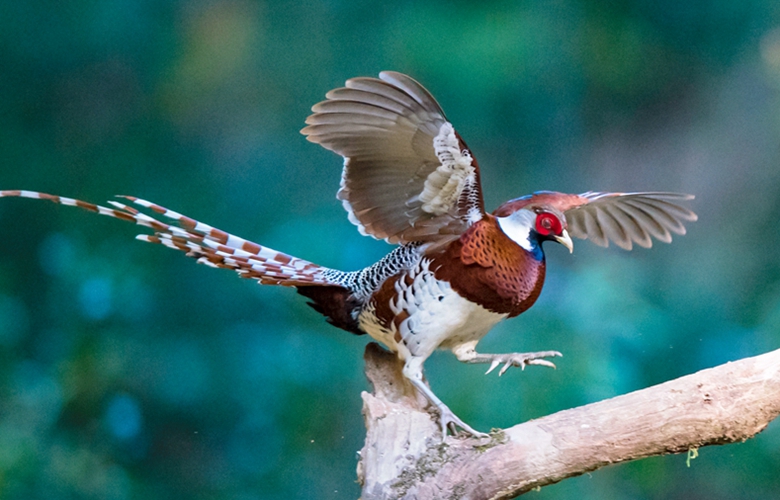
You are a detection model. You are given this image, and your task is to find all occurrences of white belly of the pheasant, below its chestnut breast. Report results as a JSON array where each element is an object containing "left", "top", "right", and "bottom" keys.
[{"left": 359, "top": 260, "right": 507, "bottom": 359}]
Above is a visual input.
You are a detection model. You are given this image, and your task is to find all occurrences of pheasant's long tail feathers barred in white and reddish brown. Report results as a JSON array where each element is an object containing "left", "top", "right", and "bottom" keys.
[{"left": 0, "top": 190, "right": 341, "bottom": 287}]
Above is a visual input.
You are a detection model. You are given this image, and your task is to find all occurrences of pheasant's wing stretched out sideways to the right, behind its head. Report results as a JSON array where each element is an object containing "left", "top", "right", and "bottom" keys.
[{"left": 494, "top": 191, "right": 697, "bottom": 250}]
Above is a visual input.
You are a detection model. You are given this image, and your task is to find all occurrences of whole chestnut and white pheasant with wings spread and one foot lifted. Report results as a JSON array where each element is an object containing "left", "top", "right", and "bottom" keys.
[{"left": 0, "top": 71, "right": 697, "bottom": 438}]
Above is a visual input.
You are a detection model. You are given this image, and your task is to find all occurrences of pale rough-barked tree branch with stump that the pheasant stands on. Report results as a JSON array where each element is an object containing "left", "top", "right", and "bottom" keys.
[{"left": 358, "top": 344, "right": 780, "bottom": 500}]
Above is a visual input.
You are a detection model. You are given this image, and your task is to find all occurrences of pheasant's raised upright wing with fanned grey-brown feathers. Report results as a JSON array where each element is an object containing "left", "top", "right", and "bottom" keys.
[{"left": 301, "top": 71, "right": 484, "bottom": 243}]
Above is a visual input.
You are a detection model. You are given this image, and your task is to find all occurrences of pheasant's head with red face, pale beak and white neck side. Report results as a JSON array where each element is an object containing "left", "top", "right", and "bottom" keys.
[{"left": 494, "top": 204, "right": 574, "bottom": 253}]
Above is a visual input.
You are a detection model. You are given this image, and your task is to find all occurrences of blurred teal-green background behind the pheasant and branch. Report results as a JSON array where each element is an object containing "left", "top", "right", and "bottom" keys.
[{"left": 0, "top": 0, "right": 780, "bottom": 500}]
